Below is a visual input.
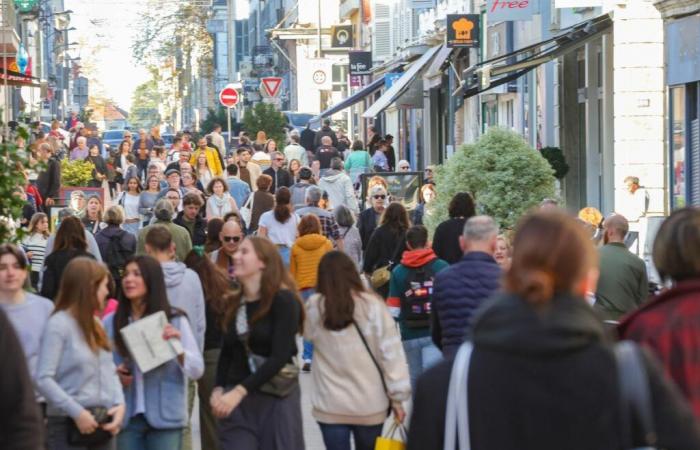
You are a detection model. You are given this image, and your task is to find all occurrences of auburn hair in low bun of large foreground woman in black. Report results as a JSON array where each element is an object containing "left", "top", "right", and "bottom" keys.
[{"left": 505, "top": 211, "right": 597, "bottom": 305}]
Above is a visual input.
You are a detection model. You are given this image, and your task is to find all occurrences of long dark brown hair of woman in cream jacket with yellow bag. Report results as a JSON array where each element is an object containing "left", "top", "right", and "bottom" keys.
[{"left": 316, "top": 250, "right": 365, "bottom": 331}]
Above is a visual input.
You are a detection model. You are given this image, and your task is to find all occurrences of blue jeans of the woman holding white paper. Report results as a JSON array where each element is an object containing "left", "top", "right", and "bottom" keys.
[{"left": 117, "top": 414, "right": 182, "bottom": 450}]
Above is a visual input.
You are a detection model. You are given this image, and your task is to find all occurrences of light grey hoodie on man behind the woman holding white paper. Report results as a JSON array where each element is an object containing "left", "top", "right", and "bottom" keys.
[{"left": 161, "top": 261, "right": 207, "bottom": 350}]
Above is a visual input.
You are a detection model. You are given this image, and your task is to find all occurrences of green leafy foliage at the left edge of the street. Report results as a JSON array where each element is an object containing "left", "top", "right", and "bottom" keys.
[{"left": 0, "top": 126, "right": 33, "bottom": 242}]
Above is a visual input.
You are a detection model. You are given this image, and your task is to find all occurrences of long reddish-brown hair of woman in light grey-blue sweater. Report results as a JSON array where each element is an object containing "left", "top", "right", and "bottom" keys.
[{"left": 54, "top": 257, "right": 110, "bottom": 352}]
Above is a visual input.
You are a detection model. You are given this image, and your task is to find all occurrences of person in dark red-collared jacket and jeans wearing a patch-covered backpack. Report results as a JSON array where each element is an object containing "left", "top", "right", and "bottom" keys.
[{"left": 387, "top": 225, "right": 449, "bottom": 386}]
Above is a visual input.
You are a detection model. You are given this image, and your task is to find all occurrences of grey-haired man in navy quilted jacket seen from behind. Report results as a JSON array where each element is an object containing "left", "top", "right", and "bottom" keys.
[{"left": 432, "top": 216, "right": 501, "bottom": 358}]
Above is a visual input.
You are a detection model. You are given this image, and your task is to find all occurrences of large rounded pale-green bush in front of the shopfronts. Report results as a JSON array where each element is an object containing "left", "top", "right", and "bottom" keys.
[{"left": 426, "top": 128, "right": 555, "bottom": 230}]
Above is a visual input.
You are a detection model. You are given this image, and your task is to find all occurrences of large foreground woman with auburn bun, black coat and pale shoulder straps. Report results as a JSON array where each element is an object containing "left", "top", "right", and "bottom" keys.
[{"left": 407, "top": 211, "right": 700, "bottom": 450}]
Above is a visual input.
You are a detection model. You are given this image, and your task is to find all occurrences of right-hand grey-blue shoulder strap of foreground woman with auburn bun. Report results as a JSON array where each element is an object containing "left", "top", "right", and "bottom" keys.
[{"left": 614, "top": 341, "right": 656, "bottom": 447}]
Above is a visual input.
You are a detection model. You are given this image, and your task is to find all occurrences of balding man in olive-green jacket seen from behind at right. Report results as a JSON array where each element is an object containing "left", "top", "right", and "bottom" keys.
[{"left": 595, "top": 214, "right": 649, "bottom": 321}]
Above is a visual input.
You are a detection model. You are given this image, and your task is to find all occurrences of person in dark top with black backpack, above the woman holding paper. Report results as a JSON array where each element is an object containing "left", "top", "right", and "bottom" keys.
[{"left": 95, "top": 205, "right": 136, "bottom": 298}]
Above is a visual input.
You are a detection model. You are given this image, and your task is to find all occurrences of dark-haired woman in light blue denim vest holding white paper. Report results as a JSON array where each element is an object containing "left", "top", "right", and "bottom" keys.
[{"left": 105, "top": 256, "right": 204, "bottom": 450}]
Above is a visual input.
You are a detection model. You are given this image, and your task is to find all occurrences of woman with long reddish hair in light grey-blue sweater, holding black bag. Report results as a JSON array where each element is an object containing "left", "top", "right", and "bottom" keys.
[{"left": 36, "top": 257, "right": 124, "bottom": 450}]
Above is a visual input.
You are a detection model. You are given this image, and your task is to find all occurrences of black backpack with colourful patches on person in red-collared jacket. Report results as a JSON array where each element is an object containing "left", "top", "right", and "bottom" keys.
[{"left": 401, "top": 259, "right": 435, "bottom": 328}]
